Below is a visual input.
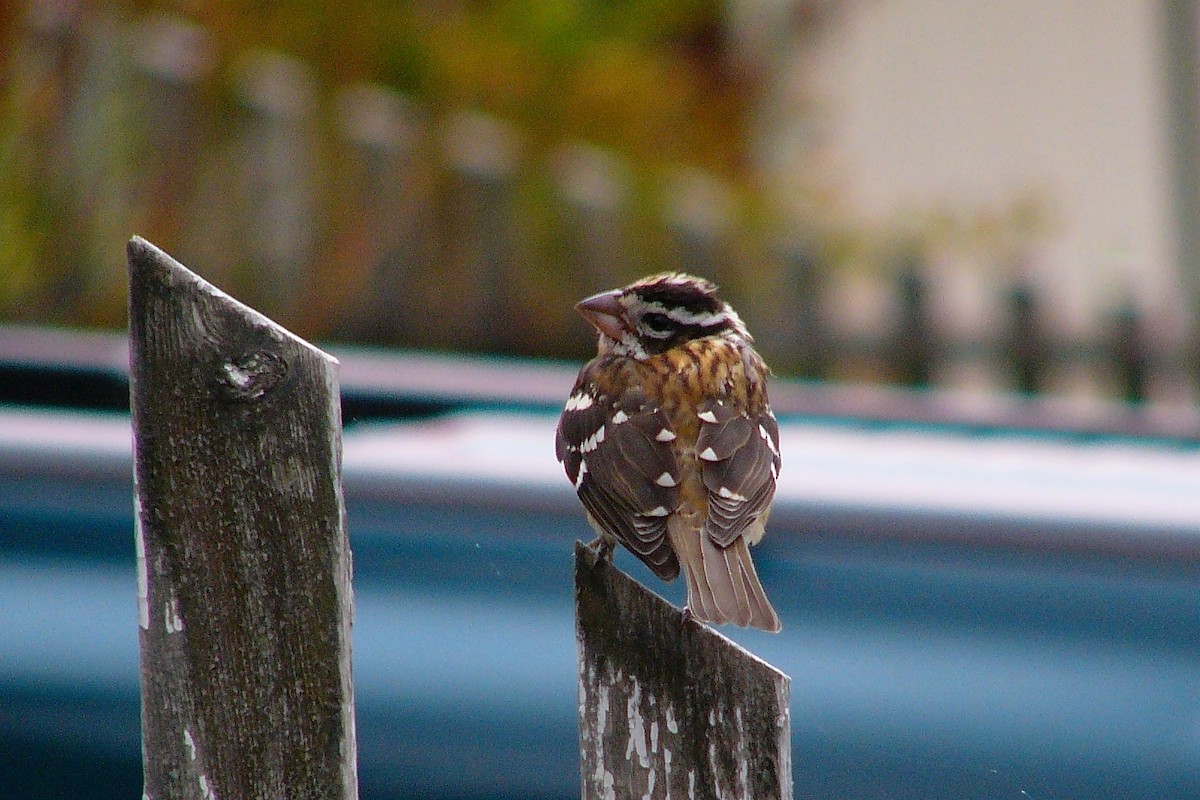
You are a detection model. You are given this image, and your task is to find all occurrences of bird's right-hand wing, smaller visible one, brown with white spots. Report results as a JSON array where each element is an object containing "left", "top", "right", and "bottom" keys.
[{"left": 696, "top": 399, "right": 780, "bottom": 547}]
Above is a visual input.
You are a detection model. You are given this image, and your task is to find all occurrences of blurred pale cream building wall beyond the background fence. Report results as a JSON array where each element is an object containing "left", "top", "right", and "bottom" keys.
[{"left": 818, "top": 0, "right": 1183, "bottom": 333}]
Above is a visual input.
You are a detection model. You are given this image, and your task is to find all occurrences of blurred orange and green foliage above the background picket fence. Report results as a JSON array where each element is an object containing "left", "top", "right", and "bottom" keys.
[{"left": 158, "top": 0, "right": 750, "bottom": 172}]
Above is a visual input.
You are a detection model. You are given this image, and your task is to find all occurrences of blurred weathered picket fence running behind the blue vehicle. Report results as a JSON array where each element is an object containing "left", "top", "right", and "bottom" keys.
[{"left": 0, "top": 11, "right": 1200, "bottom": 407}]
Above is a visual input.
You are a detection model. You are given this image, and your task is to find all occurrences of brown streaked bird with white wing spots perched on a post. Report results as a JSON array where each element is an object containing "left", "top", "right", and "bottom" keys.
[{"left": 554, "top": 272, "right": 781, "bottom": 632}]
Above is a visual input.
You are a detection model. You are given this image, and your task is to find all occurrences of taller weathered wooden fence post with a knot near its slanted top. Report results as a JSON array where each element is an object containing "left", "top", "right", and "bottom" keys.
[{"left": 128, "top": 232, "right": 358, "bottom": 800}]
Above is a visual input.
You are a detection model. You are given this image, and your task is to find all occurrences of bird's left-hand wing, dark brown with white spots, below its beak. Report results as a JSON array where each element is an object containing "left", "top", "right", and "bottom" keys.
[{"left": 554, "top": 375, "right": 679, "bottom": 581}]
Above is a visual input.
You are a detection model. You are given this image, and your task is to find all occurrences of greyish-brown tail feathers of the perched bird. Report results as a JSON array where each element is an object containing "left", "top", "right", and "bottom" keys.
[{"left": 668, "top": 525, "right": 782, "bottom": 633}]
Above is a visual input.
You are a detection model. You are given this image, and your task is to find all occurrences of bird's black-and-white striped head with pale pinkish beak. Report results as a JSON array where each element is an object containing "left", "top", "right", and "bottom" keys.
[{"left": 575, "top": 272, "right": 751, "bottom": 359}]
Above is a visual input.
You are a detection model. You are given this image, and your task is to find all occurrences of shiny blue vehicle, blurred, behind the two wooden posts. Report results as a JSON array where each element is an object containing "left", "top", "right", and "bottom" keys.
[{"left": 0, "top": 330, "right": 1200, "bottom": 800}]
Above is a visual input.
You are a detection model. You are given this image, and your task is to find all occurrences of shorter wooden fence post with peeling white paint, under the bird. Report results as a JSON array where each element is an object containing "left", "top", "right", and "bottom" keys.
[{"left": 575, "top": 543, "right": 792, "bottom": 800}]
